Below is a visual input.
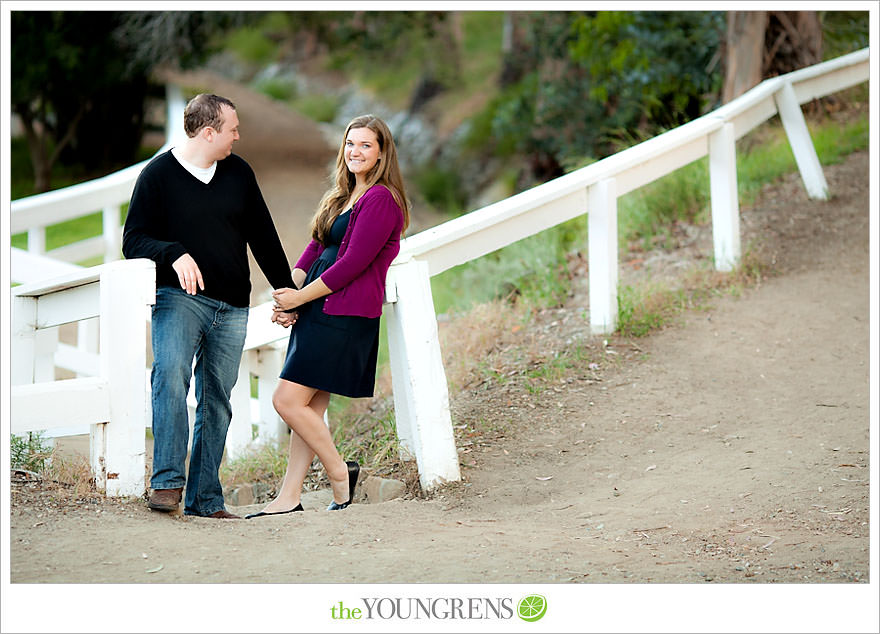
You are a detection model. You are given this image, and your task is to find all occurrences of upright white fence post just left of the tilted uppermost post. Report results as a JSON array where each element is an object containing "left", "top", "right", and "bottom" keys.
[{"left": 709, "top": 123, "right": 741, "bottom": 271}]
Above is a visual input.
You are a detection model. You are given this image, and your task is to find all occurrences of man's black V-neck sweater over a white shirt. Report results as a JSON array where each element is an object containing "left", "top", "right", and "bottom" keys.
[{"left": 122, "top": 151, "right": 293, "bottom": 306}]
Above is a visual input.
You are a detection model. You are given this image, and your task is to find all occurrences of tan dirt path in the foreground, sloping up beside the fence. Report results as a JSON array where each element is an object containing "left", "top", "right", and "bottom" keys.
[{"left": 9, "top": 73, "right": 876, "bottom": 631}]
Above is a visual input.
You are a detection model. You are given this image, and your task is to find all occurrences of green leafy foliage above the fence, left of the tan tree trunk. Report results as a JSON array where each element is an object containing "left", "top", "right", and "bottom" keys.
[{"left": 476, "top": 11, "right": 724, "bottom": 180}]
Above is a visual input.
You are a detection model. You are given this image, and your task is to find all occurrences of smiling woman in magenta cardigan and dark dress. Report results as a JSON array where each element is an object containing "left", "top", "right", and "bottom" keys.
[{"left": 247, "top": 115, "right": 409, "bottom": 519}]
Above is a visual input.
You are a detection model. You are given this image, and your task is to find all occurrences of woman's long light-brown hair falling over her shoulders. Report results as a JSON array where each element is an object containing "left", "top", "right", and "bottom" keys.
[{"left": 312, "top": 114, "right": 409, "bottom": 244}]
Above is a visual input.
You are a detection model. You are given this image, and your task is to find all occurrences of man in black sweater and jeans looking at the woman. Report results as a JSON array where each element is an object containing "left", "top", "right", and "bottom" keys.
[{"left": 122, "top": 94, "right": 293, "bottom": 519}]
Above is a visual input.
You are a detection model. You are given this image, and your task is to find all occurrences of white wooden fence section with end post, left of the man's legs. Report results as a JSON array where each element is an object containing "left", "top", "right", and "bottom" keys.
[{"left": 10, "top": 260, "right": 156, "bottom": 495}]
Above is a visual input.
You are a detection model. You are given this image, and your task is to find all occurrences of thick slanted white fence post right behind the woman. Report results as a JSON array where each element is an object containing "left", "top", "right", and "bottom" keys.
[{"left": 386, "top": 260, "right": 461, "bottom": 489}]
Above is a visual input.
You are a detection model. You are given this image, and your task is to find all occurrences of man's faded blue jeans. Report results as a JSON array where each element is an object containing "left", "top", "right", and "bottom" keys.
[{"left": 150, "top": 286, "right": 248, "bottom": 515}]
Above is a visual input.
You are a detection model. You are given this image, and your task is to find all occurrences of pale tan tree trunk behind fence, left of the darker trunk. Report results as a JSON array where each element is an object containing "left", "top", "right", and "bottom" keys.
[{"left": 721, "top": 11, "right": 768, "bottom": 103}]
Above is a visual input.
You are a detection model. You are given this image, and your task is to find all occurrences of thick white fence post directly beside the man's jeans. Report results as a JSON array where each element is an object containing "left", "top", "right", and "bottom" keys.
[{"left": 90, "top": 260, "right": 156, "bottom": 496}]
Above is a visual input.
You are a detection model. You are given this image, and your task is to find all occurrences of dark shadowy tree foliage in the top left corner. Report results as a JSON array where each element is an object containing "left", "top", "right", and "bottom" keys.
[{"left": 11, "top": 11, "right": 247, "bottom": 191}]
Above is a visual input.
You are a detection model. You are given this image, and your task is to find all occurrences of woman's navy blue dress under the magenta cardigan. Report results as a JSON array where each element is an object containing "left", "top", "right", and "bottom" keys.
[{"left": 281, "top": 210, "right": 379, "bottom": 398}]
